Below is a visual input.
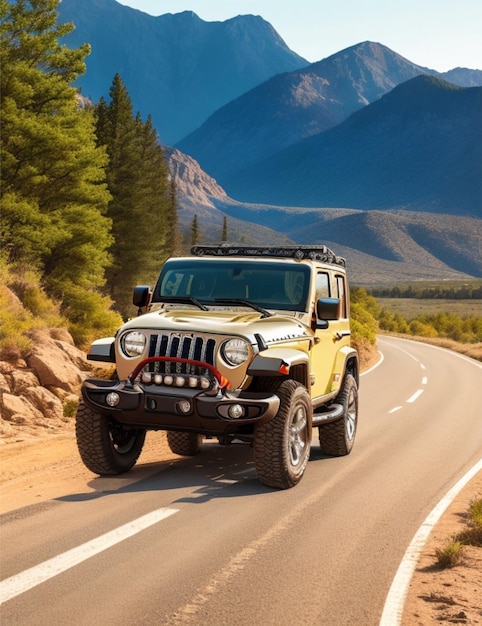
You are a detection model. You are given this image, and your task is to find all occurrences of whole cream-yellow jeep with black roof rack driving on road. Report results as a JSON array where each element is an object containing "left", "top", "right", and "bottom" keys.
[{"left": 76, "top": 244, "right": 359, "bottom": 489}]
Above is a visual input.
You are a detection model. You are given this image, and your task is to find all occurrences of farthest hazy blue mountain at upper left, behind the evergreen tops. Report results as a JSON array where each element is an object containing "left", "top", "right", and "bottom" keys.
[{"left": 59, "top": 0, "right": 308, "bottom": 144}]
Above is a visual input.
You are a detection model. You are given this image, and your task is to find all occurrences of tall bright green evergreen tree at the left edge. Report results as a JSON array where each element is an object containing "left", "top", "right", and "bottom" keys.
[{"left": 0, "top": 0, "right": 116, "bottom": 338}]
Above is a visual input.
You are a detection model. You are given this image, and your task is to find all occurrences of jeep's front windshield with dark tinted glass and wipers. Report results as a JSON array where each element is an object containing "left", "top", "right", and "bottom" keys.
[{"left": 152, "top": 258, "right": 310, "bottom": 312}]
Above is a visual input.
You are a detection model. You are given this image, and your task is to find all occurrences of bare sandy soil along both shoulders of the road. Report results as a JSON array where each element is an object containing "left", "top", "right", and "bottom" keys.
[{"left": 0, "top": 425, "right": 482, "bottom": 626}]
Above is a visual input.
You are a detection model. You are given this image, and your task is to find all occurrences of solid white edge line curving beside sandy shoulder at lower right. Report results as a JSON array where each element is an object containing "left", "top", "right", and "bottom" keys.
[{"left": 380, "top": 459, "right": 482, "bottom": 626}]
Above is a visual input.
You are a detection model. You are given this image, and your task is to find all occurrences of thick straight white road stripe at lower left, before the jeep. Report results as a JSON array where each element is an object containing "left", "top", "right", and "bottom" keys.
[{"left": 0, "top": 508, "right": 178, "bottom": 604}]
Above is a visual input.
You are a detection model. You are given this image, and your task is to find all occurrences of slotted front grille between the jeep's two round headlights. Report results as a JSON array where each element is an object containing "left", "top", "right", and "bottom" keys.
[{"left": 149, "top": 333, "right": 216, "bottom": 372}]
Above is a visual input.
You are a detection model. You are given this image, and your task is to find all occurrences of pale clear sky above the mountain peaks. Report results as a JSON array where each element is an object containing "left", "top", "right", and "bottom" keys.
[{"left": 118, "top": 0, "right": 482, "bottom": 72}]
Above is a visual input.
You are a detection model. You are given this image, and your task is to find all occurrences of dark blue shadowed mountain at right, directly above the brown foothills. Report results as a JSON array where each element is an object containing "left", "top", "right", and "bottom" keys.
[{"left": 223, "top": 76, "right": 482, "bottom": 217}]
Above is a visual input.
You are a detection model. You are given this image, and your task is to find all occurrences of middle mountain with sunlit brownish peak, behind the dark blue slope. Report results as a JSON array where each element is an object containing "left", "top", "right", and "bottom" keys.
[{"left": 177, "top": 41, "right": 482, "bottom": 184}]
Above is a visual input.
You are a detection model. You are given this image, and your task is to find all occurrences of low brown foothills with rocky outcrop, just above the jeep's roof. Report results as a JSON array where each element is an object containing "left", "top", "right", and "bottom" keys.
[{"left": 166, "top": 149, "right": 482, "bottom": 285}]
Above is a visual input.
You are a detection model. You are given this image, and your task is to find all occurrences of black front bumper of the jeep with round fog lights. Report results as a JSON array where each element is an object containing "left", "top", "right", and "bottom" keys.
[{"left": 82, "top": 378, "right": 280, "bottom": 435}]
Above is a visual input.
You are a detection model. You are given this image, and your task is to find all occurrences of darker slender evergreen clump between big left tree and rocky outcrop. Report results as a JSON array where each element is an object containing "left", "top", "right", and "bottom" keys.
[{"left": 97, "top": 75, "right": 175, "bottom": 317}]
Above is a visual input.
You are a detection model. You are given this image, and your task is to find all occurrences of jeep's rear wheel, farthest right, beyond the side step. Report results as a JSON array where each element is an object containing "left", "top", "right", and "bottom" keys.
[{"left": 318, "top": 374, "right": 358, "bottom": 456}]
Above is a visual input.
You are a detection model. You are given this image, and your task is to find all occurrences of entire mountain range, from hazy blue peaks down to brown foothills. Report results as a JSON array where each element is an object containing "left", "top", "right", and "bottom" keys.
[{"left": 59, "top": 0, "right": 482, "bottom": 284}]
